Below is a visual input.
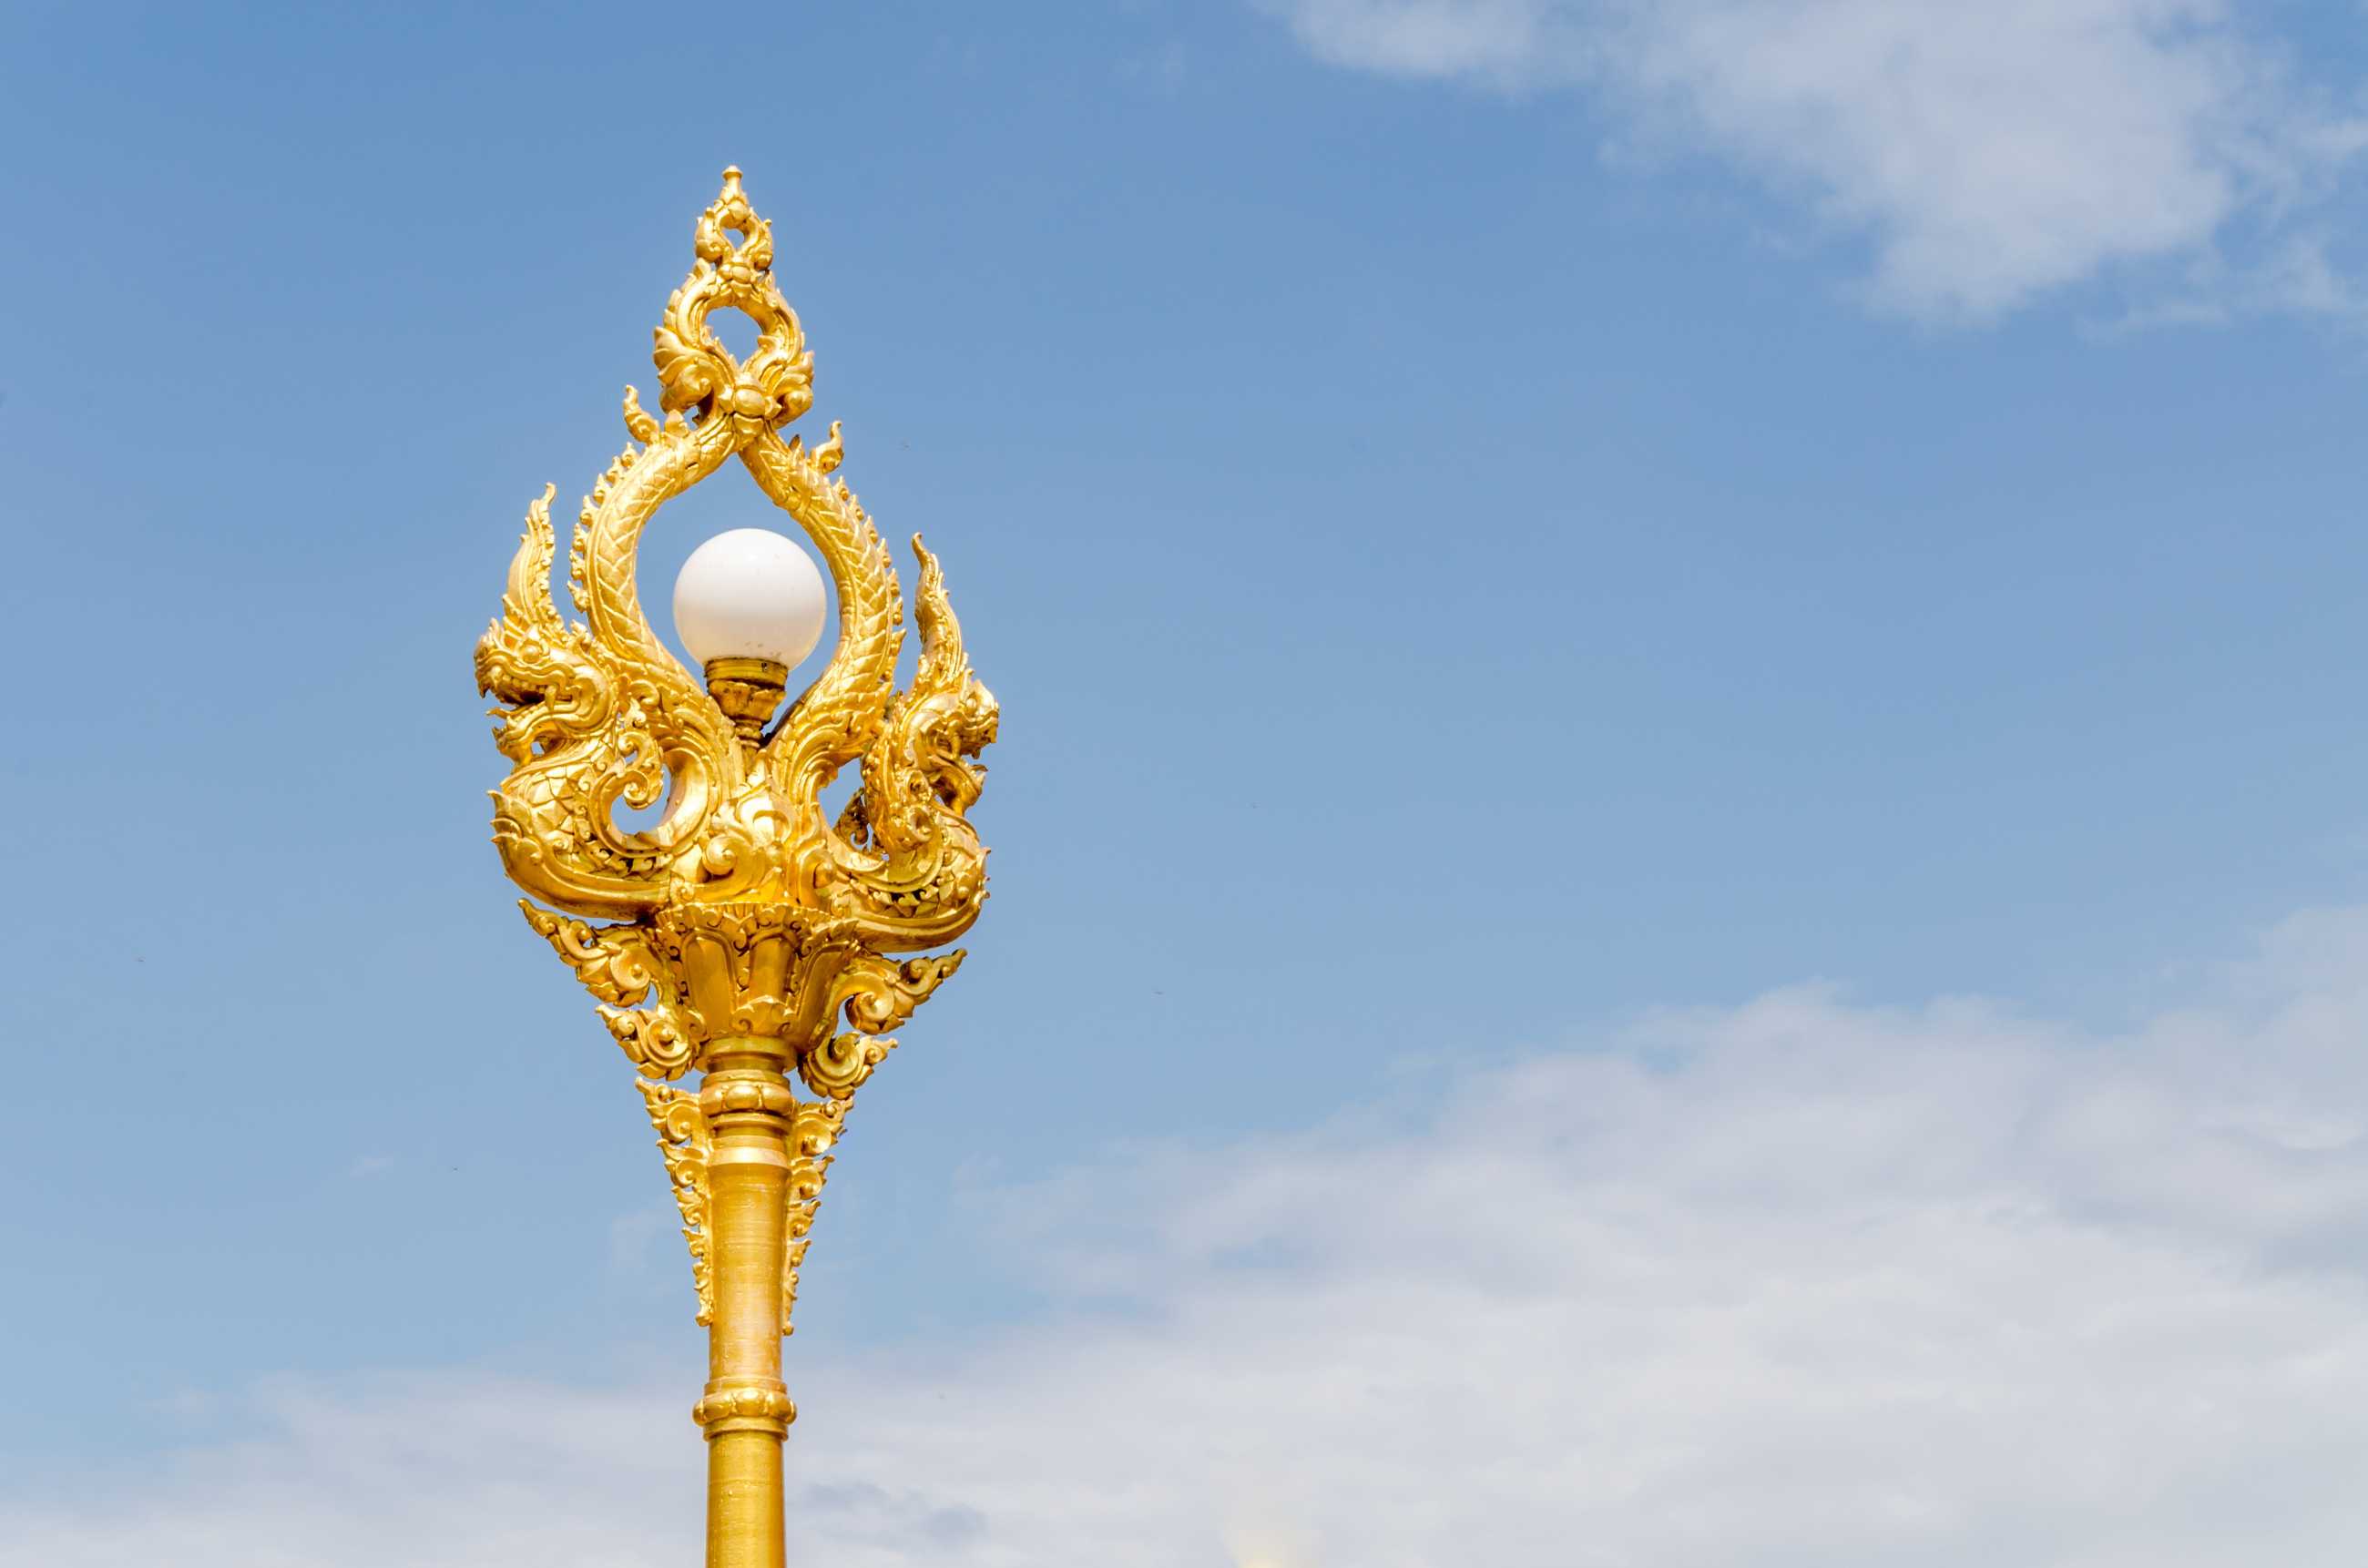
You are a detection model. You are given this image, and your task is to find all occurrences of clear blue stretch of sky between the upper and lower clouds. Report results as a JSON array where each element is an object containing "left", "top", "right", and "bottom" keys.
[{"left": 0, "top": 0, "right": 2368, "bottom": 1466}]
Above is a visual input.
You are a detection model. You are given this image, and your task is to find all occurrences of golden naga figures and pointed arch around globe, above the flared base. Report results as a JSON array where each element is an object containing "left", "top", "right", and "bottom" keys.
[{"left": 476, "top": 156, "right": 997, "bottom": 985}]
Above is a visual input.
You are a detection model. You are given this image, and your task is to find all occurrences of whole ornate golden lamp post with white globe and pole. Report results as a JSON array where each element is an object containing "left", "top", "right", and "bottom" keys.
[{"left": 476, "top": 168, "right": 995, "bottom": 1568}]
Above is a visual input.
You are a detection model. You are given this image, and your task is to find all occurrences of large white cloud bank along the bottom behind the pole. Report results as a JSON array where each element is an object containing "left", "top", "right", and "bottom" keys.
[{"left": 14, "top": 911, "right": 2368, "bottom": 1568}]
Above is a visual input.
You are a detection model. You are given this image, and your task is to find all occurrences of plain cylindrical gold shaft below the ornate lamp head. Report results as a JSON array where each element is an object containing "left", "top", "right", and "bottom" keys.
[{"left": 694, "top": 1037, "right": 798, "bottom": 1568}]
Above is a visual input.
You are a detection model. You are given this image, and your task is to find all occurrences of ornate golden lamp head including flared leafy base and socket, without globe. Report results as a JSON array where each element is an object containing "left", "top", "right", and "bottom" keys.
[{"left": 476, "top": 168, "right": 997, "bottom": 1096}]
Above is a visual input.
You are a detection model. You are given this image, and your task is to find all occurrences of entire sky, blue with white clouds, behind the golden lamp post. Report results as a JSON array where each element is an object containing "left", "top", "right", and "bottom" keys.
[{"left": 0, "top": 0, "right": 2368, "bottom": 1568}]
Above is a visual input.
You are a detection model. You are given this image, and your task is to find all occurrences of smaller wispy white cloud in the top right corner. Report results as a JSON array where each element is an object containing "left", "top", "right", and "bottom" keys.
[{"left": 1262, "top": 0, "right": 2363, "bottom": 320}]
